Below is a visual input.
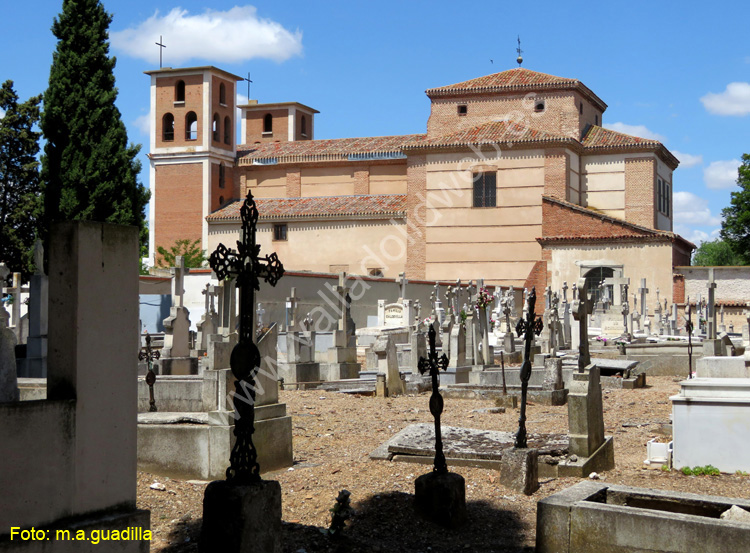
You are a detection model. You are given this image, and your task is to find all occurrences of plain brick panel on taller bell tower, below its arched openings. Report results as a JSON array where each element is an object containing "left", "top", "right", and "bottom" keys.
[{"left": 151, "top": 162, "right": 203, "bottom": 261}]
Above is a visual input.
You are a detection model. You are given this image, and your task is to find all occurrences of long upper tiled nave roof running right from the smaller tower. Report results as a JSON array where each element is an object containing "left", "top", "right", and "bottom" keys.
[{"left": 237, "top": 134, "right": 426, "bottom": 165}]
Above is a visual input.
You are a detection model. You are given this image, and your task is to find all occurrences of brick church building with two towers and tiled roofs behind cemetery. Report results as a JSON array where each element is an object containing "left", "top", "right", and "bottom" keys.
[{"left": 147, "top": 66, "right": 695, "bottom": 303}]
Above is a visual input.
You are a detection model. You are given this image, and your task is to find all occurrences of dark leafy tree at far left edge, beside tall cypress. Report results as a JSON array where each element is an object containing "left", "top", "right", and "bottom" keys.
[{"left": 0, "top": 80, "right": 42, "bottom": 280}]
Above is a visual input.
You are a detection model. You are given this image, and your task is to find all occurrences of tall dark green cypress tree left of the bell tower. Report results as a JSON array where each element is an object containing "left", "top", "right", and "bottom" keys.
[{"left": 41, "top": 0, "right": 149, "bottom": 258}]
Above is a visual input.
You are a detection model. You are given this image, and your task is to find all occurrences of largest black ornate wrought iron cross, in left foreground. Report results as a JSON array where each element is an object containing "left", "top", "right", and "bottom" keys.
[{"left": 209, "top": 192, "right": 284, "bottom": 485}]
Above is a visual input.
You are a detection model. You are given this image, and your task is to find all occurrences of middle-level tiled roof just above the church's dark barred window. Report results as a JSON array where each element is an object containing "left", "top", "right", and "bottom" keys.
[{"left": 404, "top": 121, "right": 571, "bottom": 150}]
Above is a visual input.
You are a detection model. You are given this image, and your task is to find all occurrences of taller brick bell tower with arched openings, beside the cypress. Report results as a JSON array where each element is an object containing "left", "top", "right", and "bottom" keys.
[{"left": 145, "top": 66, "right": 242, "bottom": 263}]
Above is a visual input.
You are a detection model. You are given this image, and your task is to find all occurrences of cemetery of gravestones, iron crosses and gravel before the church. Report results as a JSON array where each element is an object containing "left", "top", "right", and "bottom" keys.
[{"left": 0, "top": 195, "right": 750, "bottom": 552}]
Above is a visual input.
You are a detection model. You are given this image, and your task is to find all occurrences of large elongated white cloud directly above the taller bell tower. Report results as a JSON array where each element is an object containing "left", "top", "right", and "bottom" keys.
[{"left": 110, "top": 6, "right": 302, "bottom": 66}]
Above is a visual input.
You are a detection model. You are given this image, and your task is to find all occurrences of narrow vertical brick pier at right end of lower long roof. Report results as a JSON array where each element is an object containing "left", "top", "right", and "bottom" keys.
[{"left": 405, "top": 156, "right": 427, "bottom": 279}]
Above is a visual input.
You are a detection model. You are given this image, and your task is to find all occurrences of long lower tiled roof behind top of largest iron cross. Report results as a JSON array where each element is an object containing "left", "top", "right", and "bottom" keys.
[{"left": 206, "top": 194, "right": 406, "bottom": 221}]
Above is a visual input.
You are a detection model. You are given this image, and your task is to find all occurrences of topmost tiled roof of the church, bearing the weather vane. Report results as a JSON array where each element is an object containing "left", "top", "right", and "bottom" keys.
[{"left": 426, "top": 67, "right": 607, "bottom": 110}]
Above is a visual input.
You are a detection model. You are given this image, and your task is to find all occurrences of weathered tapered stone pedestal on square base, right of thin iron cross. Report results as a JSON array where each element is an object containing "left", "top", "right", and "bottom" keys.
[{"left": 558, "top": 365, "right": 615, "bottom": 477}]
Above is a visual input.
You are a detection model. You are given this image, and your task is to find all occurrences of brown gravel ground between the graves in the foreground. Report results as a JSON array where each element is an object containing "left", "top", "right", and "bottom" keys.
[{"left": 138, "top": 377, "right": 750, "bottom": 553}]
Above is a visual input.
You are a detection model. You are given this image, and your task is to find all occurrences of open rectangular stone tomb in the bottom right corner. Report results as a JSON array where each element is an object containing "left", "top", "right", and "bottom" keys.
[{"left": 536, "top": 481, "right": 750, "bottom": 553}]
